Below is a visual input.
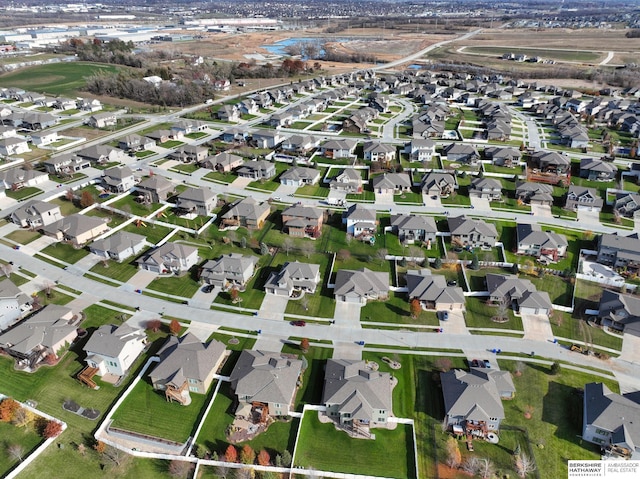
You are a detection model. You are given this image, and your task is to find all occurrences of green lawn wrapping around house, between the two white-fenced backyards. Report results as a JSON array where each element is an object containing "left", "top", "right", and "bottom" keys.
[{"left": 196, "top": 382, "right": 297, "bottom": 459}]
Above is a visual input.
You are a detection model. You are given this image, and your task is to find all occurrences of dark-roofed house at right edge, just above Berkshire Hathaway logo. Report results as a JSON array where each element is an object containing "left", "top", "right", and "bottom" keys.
[{"left": 582, "top": 383, "right": 640, "bottom": 461}]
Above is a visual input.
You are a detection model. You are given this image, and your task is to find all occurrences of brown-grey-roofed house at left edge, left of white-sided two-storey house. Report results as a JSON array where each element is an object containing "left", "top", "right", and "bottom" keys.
[{"left": 0, "top": 304, "right": 78, "bottom": 370}]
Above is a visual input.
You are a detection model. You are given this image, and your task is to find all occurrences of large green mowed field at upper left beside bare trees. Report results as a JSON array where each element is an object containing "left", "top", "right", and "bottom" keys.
[{"left": 0, "top": 62, "right": 122, "bottom": 97}]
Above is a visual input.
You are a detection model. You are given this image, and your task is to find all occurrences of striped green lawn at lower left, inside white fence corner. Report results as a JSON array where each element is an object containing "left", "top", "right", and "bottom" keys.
[{"left": 112, "top": 375, "right": 209, "bottom": 442}]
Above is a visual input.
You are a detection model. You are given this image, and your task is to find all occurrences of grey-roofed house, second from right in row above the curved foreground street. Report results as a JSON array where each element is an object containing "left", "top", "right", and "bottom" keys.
[{"left": 486, "top": 273, "right": 552, "bottom": 316}]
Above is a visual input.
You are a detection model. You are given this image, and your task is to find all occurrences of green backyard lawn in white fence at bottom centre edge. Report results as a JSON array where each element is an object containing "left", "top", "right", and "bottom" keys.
[{"left": 295, "top": 412, "right": 416, "bottom": 479}]
